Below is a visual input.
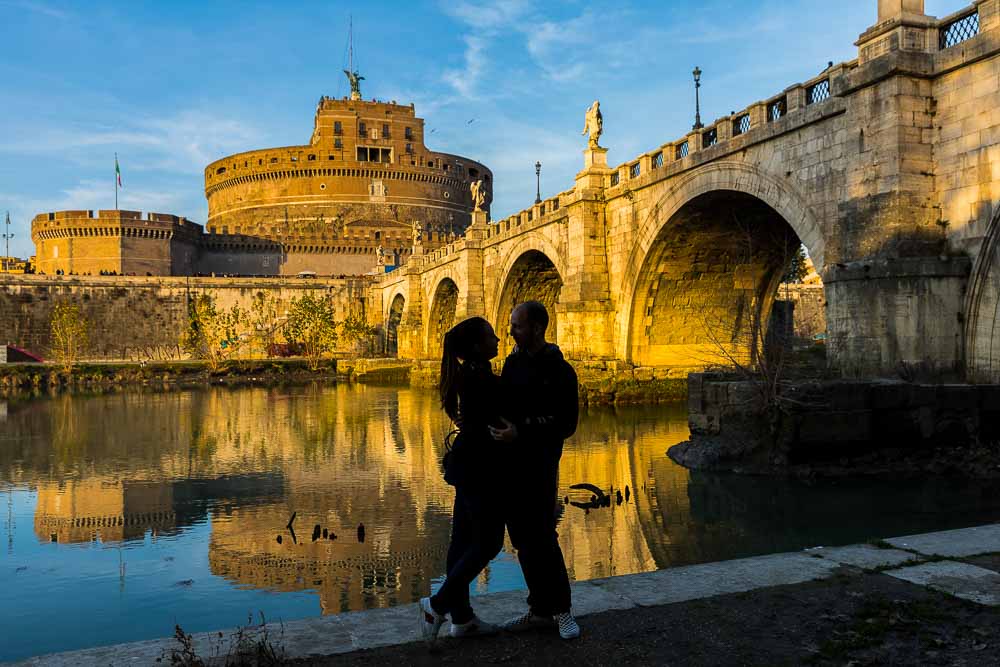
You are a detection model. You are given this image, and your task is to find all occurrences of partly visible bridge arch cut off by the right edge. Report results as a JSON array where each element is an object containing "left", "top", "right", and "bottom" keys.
[{"left": 965, "top": 207, "right": 1000, "bottom": 382}]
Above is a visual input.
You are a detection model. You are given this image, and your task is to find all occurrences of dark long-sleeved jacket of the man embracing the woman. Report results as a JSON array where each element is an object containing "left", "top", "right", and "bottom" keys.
[{"left": 500, "top": 343, "right": 579, "bottom": 475}]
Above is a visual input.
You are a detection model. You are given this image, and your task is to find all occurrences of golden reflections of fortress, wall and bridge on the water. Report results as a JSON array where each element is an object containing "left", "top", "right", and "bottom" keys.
[{"left": 0, "top": 385, "right": 699, "bottom": 613}]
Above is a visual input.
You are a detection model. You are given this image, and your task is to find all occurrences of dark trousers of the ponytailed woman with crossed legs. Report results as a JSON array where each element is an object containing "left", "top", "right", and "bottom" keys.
[{"left": 431, "top": 485, "right": 504, "bottom": 623}]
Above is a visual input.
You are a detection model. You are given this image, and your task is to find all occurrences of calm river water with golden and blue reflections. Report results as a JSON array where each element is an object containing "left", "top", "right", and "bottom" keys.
[{"left": 0, "top": 384, "right": 1000, "bottom": 661}]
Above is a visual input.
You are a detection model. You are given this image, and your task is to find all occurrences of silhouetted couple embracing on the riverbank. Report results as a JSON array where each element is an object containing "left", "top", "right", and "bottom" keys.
[{"left": 419, "top": 301, "right": 580, "bottom": 643}]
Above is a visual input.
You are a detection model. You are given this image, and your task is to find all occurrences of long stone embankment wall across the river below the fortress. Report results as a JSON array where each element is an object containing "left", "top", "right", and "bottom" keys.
[{"left": 0, "top": 275, "right": 369, "bottom": 360}]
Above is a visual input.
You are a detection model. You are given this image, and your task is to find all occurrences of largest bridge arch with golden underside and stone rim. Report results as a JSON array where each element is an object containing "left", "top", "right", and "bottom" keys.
[{"left": 616, "top": 162, "right": 824, "bottom": 368}]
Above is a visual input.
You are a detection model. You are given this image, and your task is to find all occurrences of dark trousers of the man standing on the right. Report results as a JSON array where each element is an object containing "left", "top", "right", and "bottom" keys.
[{"left": 506, "top": 469, "right": 570, "bottom": 616}]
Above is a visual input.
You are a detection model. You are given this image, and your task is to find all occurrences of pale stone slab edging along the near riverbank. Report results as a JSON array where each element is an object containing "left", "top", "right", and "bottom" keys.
[{"left": 11, "top": 524, "right": 1000, "bottom": 666}]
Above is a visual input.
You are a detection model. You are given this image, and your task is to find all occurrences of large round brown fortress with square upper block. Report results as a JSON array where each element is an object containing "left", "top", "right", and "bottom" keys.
[{"left": 200, "top": 97, "right": 493, "bottom": 275}]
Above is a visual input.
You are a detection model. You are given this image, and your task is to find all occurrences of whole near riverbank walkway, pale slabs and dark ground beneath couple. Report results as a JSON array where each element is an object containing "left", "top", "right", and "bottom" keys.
[{"left": 16, "top": 524, "right": 1000, "bottom": 667}]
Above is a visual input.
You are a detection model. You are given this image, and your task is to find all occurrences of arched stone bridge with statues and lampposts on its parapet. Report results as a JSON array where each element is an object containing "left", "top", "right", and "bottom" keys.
[{"left": 375, "top": 0, "right": 1000, "bottom": 380}]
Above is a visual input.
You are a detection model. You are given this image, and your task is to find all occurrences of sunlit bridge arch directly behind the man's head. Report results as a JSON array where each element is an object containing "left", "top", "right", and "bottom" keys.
[{"left": 493, "top": 248, "right": 563, "bottom": 358}]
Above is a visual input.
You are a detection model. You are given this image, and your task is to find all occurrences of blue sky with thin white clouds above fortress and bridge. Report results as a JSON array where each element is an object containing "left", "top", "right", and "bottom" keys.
[{"left": 0, "top": 0, "right": 969, "bottom": 256}]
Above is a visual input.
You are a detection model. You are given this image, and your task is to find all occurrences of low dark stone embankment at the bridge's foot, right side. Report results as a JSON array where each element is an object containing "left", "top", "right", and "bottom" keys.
[{"left": 684, "top": 373, "right": 1000, "bottom": 467}]
